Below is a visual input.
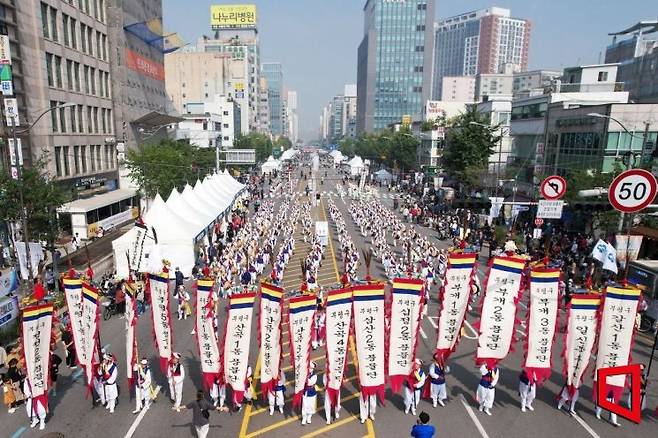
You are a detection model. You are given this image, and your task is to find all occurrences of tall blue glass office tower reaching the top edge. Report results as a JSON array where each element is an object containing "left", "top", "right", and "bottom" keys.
[{"left": 357, "top": 0, "right": 436, "bottom": 133}]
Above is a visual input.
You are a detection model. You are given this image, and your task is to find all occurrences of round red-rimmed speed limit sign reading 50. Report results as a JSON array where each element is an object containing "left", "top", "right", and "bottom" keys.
[{"left": 608, "top": 169, "right": 657, "bottom": 213}]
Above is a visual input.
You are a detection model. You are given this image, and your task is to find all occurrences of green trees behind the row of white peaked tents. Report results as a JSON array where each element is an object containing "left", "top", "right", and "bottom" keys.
[{"left": 126, "top": 140, "right": 204, "bottom": 198}]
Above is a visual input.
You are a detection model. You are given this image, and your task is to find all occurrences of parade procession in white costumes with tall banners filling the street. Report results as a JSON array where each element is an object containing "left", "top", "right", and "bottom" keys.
[{"left": 3, "top": 153, "right": 656, "bottom": 437}]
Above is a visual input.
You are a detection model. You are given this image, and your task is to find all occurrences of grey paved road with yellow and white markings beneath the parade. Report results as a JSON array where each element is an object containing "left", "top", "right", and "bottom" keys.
[{"left": 0, "top": 164, "right": 658, "bottom": 438}]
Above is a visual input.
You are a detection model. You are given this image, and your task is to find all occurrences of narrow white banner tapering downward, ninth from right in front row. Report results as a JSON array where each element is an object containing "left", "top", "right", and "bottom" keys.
[{"left": 288, "top": 295, "right": 317, "bottom": 407}]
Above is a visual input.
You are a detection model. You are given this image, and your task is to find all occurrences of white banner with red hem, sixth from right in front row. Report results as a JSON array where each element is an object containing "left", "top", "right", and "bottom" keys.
[{"left": 386, "top": 278, "right": 424, "bottom": 392}]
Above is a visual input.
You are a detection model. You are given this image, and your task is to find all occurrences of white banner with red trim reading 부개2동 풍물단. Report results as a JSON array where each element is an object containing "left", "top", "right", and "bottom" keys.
[{"left": 476, "top": 257, "right": 525, "bottom": 368}]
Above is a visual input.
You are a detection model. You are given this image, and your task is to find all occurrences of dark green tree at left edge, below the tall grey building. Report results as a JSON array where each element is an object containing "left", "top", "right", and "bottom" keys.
[{"left": 0, "top": 157, "right": 68, "bottom": 243}]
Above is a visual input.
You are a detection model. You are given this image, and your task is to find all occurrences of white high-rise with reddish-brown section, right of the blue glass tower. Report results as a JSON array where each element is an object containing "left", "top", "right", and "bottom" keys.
[{"left": 432, "top": 7, "right": 531, "bottom": 99}]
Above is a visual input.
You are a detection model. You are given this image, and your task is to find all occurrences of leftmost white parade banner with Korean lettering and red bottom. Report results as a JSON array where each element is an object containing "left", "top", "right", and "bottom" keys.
[{"left": 21, "top": 304, "right": 53, "bottom": 416}]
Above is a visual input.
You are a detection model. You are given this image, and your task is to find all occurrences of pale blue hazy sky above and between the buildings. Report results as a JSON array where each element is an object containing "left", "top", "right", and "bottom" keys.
[{"left": 162, "top": 0, "right": 657, "bottom": 140}]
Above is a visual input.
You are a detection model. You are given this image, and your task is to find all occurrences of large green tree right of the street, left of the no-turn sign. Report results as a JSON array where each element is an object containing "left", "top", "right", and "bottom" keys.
[{"left": 443, "top": 107, "right": 500, "bottom": 190}]
